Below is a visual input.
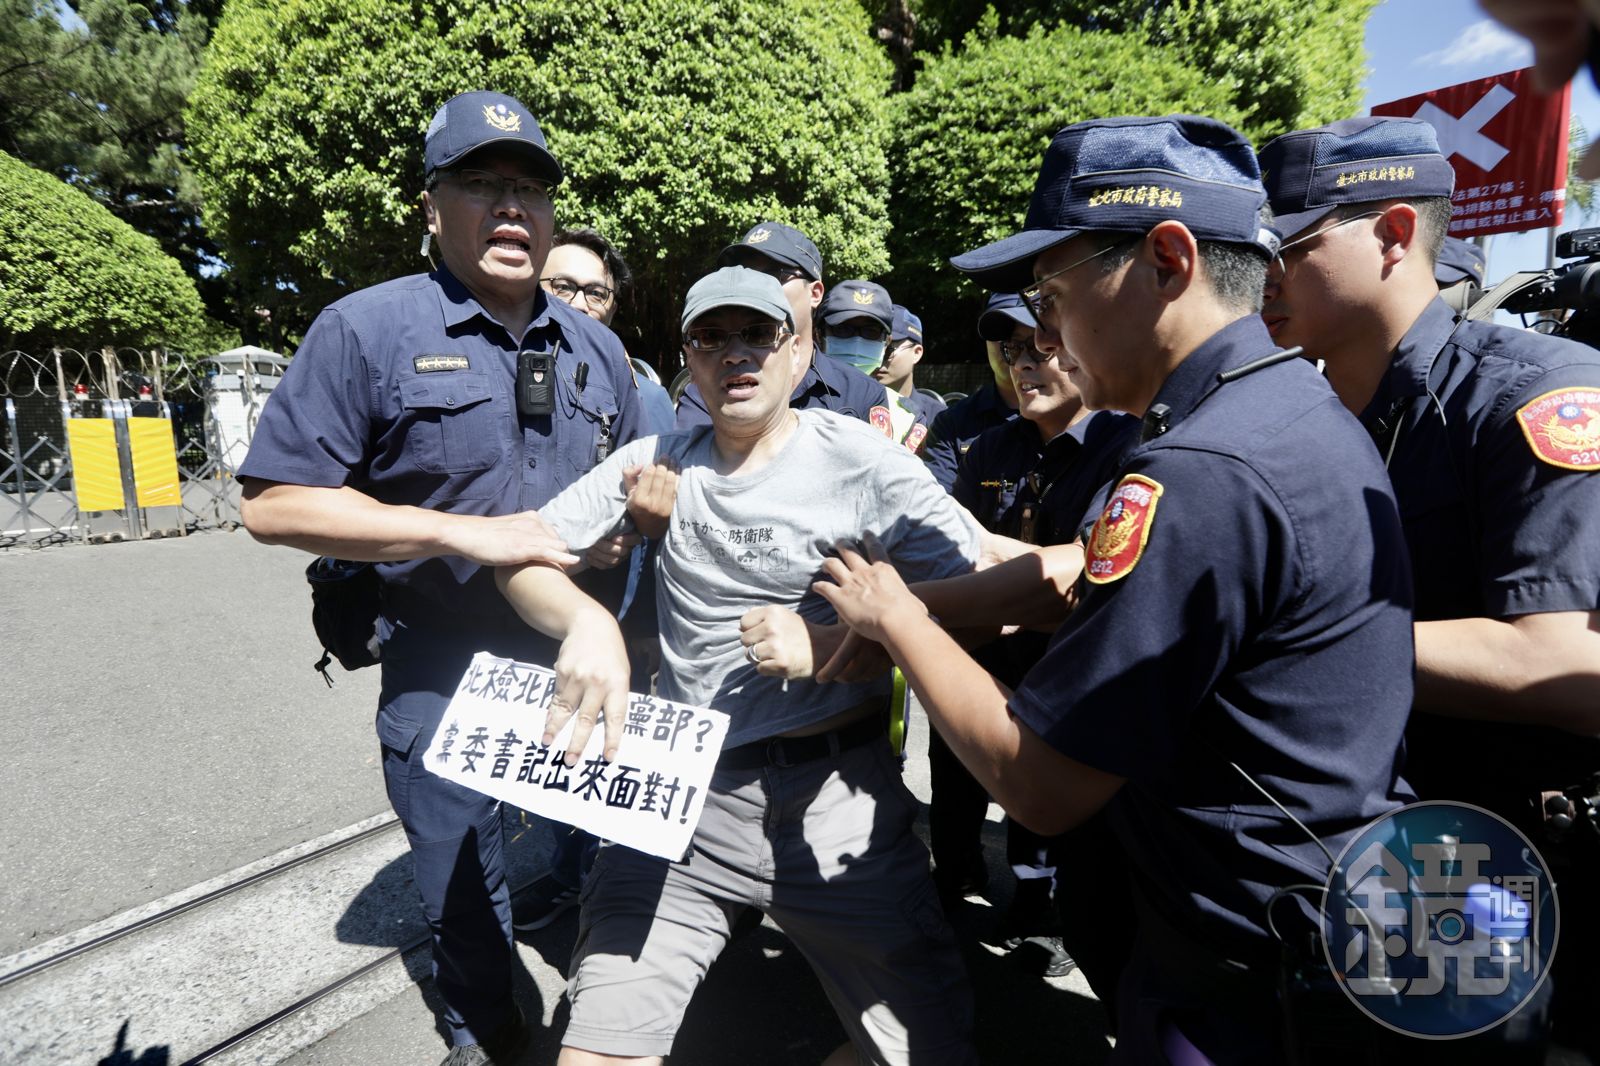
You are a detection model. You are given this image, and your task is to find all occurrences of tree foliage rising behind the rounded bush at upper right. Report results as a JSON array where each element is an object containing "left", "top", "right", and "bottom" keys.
[{"left": 914, "top": 0, "right": 1378, "bottom": 142}]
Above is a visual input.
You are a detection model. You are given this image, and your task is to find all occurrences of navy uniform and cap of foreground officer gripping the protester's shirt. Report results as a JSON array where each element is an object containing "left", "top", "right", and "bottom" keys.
[{"left": 952, "top": 115, "right": 1411, "bottom": 1063}]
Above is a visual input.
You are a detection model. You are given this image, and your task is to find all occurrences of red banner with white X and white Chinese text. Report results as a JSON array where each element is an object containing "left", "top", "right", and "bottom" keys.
[{"left": 1373, "top": 69, "right": 1573, "bottom": 237}]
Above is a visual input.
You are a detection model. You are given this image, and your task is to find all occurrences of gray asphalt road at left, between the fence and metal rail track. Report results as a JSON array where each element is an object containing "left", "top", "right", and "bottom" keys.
[{"left": 0, "top": 531, "right": 389, "bottom": 957}]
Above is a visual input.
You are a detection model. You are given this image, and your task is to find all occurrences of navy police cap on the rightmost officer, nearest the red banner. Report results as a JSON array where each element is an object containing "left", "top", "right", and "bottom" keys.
[{"left": 1261, "top": 115, "right": 1456, "bottom": 238}]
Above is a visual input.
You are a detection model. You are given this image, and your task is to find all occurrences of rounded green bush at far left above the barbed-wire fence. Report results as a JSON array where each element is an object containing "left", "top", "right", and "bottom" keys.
[{"left": 0, "top": 152, "right": 229, "bottom": 352}]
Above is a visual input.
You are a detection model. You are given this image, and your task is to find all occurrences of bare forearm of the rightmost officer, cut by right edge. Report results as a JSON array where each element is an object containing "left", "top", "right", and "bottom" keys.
[{"left": 1416, "top": 611, "right": 1600, "bottom": 736}]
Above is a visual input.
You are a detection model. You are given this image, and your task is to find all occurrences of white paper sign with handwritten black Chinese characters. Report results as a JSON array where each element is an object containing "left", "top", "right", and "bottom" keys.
[{"left": 424, "top": 651, "right": 728, "bottom": 860}]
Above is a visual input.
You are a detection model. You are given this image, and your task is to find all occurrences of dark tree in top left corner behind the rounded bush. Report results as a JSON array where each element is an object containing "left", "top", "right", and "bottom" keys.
[{"left": 0, "top": 0, "right": 227, "bottom": 314}]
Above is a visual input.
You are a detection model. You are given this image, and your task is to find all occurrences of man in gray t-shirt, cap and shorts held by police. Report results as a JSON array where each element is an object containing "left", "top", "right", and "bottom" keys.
[{"left": 499, "top": 267, "right": 979, "bottom": 1066}]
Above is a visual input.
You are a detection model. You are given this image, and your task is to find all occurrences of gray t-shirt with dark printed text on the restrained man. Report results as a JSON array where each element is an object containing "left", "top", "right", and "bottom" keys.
[{"left": 539, "top": 410, "right": 979, "bottom": 747}]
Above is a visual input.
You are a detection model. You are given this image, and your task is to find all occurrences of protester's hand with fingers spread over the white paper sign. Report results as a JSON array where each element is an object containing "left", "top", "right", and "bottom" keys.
[{"left": 544, "top": 607, "right": 629, "bottom": 767}]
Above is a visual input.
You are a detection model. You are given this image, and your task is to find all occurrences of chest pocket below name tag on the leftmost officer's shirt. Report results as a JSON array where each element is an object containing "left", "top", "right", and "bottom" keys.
[{"left": 400, "top": 373, "right": 501, "bottom": 474}]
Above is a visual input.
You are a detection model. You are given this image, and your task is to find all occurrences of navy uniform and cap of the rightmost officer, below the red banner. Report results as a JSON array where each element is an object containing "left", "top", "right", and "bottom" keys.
[{"left": 1261, "top": 118, "right": 1600, "bottom": 1058}]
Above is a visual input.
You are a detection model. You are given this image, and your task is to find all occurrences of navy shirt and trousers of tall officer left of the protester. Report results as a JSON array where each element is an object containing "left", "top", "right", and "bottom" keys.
[{"left": 240, "top": 260, "right": 642, "bottom": 1044}]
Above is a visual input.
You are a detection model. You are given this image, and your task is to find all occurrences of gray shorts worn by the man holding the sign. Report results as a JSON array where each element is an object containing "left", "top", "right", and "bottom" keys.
[{"left": 562, "top": 739, "right": 976, "bottom": 1066}]
